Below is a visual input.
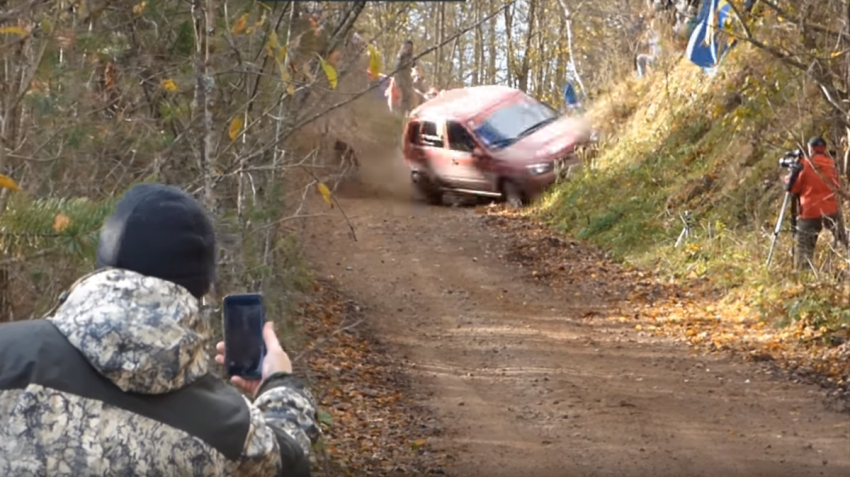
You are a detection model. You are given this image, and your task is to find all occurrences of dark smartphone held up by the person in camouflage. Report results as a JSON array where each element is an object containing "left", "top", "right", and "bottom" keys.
[{"left": 222, "top": 293, "right": 266, "bottom": 379}]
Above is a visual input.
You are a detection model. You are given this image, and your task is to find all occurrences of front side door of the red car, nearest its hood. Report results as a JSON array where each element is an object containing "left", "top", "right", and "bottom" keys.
[{"left": 446, "top": 121, "right": 492, "bottom": 192}]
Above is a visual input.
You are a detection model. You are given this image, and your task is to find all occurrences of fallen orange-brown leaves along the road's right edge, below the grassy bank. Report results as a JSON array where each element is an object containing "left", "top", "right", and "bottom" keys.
[{"left": 478, "top": 207, "right": 850, "bottom": 411}]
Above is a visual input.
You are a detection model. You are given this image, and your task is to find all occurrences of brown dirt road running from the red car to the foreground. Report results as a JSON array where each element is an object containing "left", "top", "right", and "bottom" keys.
[{"left": 310, "top": 194, "right": 850, "bottom": 477}]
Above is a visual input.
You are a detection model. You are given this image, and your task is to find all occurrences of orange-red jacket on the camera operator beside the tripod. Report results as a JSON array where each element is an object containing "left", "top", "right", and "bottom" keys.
[{"left": 786, "top": 154, "right": 839, "bottom": 219}]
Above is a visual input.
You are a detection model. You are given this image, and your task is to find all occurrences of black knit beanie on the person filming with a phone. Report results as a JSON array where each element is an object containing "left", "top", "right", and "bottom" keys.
[{"left": 97, "top": 184, "right": 216, "bottom": 298}]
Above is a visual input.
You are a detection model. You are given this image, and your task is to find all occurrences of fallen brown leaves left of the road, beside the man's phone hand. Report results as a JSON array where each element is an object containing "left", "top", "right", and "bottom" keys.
[{"left": 292, "top": 279, "right": 451, "bottom": 477}]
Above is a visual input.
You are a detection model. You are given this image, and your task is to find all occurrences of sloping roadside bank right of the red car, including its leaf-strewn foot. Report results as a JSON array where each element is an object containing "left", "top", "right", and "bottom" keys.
[{"left": 534, "top": 46, "right": 850, "bottom": 402}]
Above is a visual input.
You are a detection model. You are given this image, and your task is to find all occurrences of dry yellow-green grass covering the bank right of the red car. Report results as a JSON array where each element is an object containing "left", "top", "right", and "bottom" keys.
[{"left": 536, "top": 41, "right": 850, "bottom": 332}]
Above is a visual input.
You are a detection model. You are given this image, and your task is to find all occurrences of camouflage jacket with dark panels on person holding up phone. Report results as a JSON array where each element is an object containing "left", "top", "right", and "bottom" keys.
[{"left": 0, "top": 269, "right": 319, "bottom": 477}]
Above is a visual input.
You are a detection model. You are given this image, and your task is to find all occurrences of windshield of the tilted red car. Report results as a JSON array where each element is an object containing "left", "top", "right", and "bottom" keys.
[{"left": 475, "top": 98, "right": 558, "bottom": 149}]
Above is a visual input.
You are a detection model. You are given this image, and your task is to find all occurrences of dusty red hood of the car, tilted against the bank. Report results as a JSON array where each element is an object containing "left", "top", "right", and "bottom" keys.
[{"left": 494, "top": 116, "right": 590, "bottom": 164}]
